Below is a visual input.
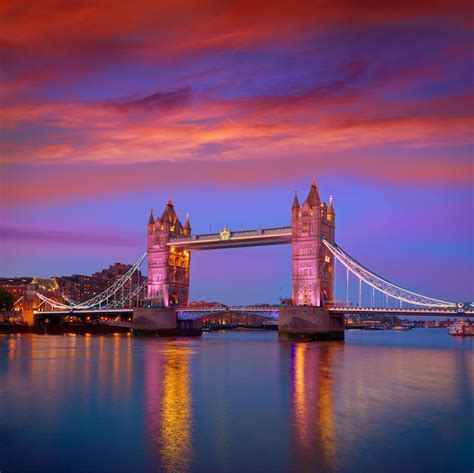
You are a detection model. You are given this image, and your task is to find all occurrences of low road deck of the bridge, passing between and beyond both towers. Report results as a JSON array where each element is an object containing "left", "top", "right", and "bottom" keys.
[{"left": 35, "top": 305, "right": 474, "bottom": 320}]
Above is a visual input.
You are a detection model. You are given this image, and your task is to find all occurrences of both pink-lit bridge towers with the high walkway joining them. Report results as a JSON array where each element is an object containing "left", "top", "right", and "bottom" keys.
[{"left": 147, "top": 181, "right": 336, "bottom": 307}]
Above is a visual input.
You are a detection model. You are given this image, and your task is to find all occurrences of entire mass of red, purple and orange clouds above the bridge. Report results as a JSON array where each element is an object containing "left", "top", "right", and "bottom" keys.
[{"left": 0, "top": 0, "right": 474, "bottom": 202}]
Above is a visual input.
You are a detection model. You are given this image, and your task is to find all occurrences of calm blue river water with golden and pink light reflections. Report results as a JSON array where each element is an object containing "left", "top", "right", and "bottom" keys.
[{"left": 0, "top": 329, "right": 474, "bottom": 473}]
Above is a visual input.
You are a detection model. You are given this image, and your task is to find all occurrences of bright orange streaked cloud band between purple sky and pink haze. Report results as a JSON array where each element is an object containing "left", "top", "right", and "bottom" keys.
[{"left": 0, "top": 85, "right": 474, "bottom": 166}]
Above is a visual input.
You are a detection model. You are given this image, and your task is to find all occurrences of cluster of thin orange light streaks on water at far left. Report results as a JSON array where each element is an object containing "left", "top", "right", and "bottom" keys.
[{"left": 2, "top": 335, "right": 133, "bottom": 405}]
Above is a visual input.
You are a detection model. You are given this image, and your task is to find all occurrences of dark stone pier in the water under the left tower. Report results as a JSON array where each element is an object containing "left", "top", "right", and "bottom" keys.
[{"left": 132, "top": 307, "right": 202, "bottom": 337}]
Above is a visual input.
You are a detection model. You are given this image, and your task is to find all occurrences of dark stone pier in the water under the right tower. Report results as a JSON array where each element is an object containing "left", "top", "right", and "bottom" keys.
[{"left": 278, "top": 306, "right": 344, "bottom": 340}]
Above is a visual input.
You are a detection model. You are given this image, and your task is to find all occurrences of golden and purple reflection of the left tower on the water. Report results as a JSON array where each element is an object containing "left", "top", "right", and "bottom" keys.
[{"left": 145, "top": 341, "right": 193, "bottom": 471}]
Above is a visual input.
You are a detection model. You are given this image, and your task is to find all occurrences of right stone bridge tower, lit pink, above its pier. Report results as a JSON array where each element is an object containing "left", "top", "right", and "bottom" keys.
[{"left": 291, "top": 181, "right": 336, "bottom": 306}]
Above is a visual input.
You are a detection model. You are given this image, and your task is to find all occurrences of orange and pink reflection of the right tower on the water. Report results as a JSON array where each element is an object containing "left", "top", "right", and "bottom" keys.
[{"left": 291, "top": 343, "right": 343, "bottom": 471}]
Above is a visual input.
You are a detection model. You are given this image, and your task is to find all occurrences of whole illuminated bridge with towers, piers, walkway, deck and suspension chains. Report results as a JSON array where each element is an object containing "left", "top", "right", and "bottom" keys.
[{"left": 31, "top": 181, "right": 474, "bottom": 338}]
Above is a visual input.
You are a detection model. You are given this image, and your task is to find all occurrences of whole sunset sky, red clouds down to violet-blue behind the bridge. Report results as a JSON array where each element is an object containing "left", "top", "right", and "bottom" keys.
[{"left": 0, "top": 0, "right": 474, "bottom": 303}]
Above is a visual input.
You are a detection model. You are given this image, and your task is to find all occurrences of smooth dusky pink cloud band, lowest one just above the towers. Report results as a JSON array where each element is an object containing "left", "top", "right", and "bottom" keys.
[{"left": 0, "top": 149, "right": 474, "bottom": 208}]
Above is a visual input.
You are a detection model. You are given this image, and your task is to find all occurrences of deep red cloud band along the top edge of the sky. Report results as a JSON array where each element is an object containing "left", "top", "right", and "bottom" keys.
[{"left": 0, "top": 0, "right": 472, "bottom": 88}]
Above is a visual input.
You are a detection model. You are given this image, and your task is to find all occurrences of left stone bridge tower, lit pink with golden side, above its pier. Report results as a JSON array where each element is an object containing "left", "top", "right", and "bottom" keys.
[{"left": 147, "top": 200, "right": 191, "bottom": 307}]
